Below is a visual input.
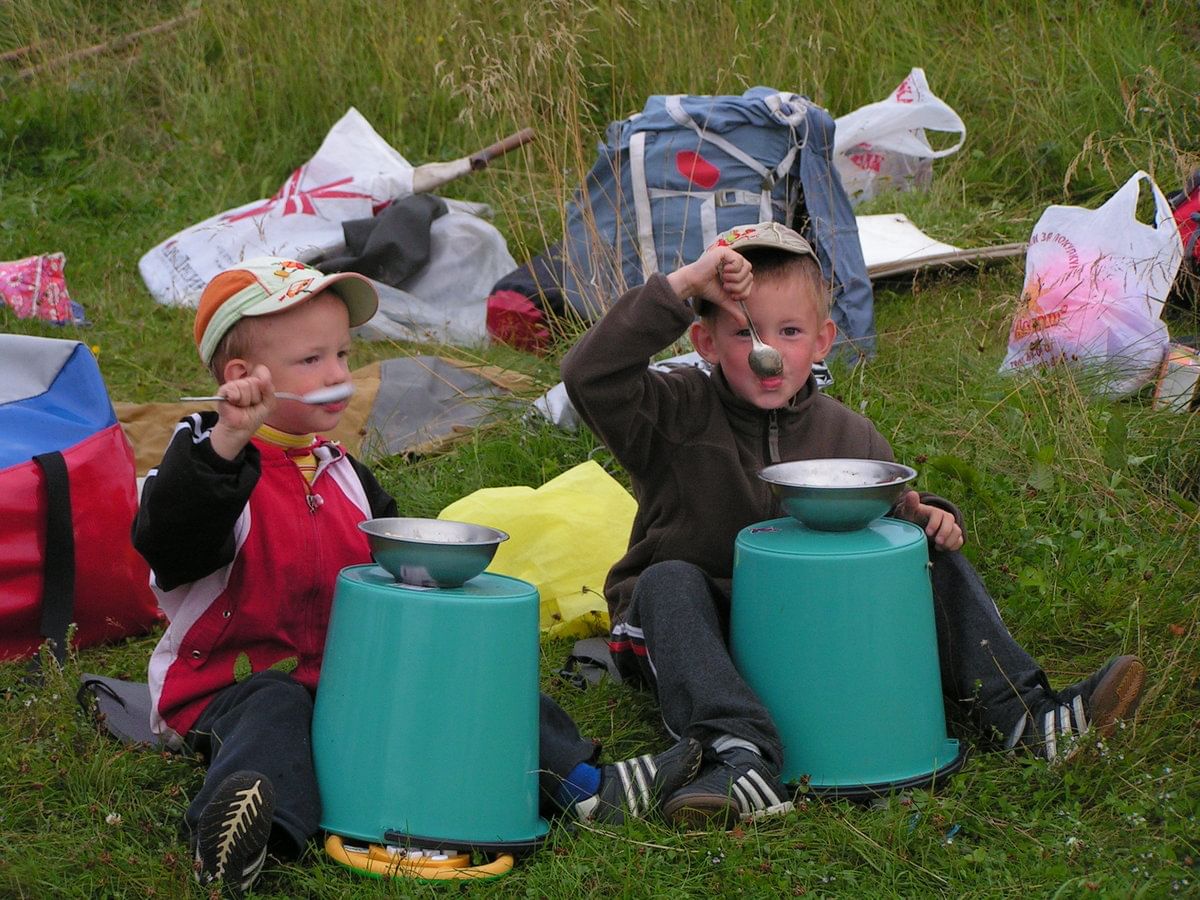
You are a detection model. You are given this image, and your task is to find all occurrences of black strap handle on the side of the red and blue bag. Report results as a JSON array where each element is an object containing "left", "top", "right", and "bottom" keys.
[{"left": 32, "top": 450, "right": 76, "bottom": 670}]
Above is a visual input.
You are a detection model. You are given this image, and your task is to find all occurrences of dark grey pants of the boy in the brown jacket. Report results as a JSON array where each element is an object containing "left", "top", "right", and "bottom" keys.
[{"left": 618, "top": 550, "right": 1052, "bottom": 772}]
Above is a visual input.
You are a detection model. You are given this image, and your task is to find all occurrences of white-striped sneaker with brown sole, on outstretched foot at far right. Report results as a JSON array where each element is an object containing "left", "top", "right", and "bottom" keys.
[{"left": 1004, "top": 656, "right": 1146, "bottom": 762}]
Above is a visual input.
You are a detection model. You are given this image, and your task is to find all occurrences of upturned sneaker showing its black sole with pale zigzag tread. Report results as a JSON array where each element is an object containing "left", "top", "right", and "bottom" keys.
[{"left": 196, "top": 772, "right": 275, "bottom": 898}]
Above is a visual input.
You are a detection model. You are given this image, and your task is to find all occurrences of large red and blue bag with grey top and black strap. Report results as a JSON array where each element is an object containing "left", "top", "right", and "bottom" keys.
[{"left": 0, "top": 335, "right": 160, "bottom": 660}]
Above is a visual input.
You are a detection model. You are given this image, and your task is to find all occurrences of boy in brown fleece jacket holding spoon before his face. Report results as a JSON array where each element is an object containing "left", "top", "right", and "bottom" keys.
[{"left": 563, "top": 222, "right": 1145, "bottom": 827}]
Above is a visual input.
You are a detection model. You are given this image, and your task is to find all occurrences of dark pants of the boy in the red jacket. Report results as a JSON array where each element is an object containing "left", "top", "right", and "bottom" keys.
[{"left": 184, "top": 670, "right": 599, "bottom": 857}]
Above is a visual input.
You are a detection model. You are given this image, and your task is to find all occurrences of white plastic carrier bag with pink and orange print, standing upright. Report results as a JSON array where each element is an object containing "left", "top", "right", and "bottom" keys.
[{"left": 1000, "top": 172, "right": 1183, "bottom": 396}]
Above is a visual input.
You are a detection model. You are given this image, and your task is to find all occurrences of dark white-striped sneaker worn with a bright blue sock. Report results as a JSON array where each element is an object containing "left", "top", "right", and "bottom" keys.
[{"left": 575, "top": 738, "right": 703, "bottom": 824}]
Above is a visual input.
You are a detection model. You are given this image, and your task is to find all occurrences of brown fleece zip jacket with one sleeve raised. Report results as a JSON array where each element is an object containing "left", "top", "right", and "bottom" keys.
[{"left": 562, "top": 275, "right": 961, "bottom": 623}]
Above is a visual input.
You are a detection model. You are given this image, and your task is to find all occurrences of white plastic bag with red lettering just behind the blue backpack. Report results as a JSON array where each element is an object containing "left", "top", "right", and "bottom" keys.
[{"left": 833, "top": 68, "right": 967, "bottom": 204}]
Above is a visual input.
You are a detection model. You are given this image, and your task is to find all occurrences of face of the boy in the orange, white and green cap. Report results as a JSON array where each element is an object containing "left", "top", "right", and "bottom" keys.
[{"left": 232, "top": 290, "right": 350, "bottom": 434}]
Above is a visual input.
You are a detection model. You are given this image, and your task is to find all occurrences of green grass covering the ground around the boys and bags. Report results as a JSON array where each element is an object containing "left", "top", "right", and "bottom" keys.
[{"left": 0, "top": 0, "right": 1200, "bottom": 898}]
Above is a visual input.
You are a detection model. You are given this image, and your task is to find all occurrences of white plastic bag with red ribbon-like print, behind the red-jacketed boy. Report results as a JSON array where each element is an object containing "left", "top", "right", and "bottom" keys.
[{"left": 138, "top": 107, "right": 413, "bottom": 306}]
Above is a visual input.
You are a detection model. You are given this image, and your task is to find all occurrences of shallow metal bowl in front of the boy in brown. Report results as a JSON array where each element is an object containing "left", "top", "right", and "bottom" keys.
[{"left": 758, "top": 460, "right": 917, "bottom": 532}]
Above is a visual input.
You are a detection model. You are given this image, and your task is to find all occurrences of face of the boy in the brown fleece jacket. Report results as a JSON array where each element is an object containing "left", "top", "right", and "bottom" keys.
[{"left": 691, "top": 272, "right": 838, "bottom": 409}]
